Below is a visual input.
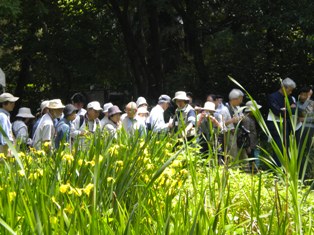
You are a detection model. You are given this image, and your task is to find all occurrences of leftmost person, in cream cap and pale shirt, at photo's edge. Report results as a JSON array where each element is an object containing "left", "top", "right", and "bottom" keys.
[{"left": 0, "top": 93, "right": 19, "bottom": 156}]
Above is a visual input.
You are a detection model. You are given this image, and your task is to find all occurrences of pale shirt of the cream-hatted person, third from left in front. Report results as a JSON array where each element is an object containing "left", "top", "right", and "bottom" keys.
[{"left": 33, "top": 113, "right": 55, "bottom": 149}]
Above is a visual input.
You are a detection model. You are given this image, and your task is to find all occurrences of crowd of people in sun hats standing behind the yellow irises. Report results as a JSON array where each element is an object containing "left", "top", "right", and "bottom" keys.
[{"left": 0, "top": 78, "right": 314, "bottom": 173}]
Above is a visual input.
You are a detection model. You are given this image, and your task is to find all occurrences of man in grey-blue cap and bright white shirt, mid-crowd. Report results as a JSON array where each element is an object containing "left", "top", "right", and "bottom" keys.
[{"left": 147, "top": 95, "right": 172, "bottom": 133}]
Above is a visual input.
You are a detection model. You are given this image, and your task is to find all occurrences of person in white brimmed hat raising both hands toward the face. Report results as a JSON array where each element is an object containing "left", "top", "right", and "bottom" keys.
[{"left": 197, "top": 101, "right": 223, "bottom": 153}]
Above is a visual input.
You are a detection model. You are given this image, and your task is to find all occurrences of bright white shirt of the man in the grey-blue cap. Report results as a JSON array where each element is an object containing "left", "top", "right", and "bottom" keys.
[{"left": 147, "top": 104, "right": 168, "bottom": 132}]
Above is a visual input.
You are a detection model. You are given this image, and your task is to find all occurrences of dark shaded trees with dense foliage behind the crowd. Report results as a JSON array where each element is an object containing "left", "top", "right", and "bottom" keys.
[{"left": 0, "top": 0, "right": 314, "bottom": 110}]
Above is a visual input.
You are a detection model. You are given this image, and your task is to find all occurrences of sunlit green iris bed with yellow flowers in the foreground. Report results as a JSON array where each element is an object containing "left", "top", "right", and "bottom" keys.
[{"left": 0, "top": 79, "right": 314, "bottom": 234}]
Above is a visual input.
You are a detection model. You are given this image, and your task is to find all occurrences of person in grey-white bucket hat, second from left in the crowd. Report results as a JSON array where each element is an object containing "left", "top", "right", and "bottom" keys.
[{"left": 12, "top": 107, "right": 35, "bottom": 145}]
